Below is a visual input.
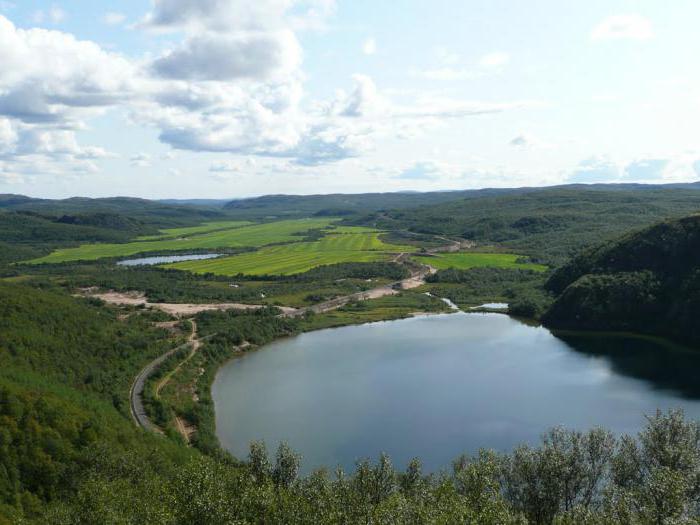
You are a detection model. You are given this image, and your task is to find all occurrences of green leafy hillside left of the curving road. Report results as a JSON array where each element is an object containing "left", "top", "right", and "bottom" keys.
[{"left": 0, "top": 283, "right": 194, "bottom": 523}]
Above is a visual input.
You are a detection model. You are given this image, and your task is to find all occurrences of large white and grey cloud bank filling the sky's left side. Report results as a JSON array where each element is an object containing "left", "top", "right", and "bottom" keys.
[{"left": 0, "top": 0, "right": 534, "bottom": 178}]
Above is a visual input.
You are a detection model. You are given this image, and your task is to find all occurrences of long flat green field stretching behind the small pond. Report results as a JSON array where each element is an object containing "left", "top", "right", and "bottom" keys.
[{"left": 29, "top": 218, "right": 337, "bottom": 264}]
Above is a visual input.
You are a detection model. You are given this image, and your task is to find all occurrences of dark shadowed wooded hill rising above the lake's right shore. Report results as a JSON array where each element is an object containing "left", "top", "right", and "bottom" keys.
[{"left": 544, "top": 215, "right": 700, "bottom": 343}]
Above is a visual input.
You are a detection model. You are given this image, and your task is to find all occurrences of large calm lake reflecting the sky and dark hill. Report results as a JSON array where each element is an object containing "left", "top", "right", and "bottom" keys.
[{"left": 213, "top": 313, "right": 700, "bottom": 472}]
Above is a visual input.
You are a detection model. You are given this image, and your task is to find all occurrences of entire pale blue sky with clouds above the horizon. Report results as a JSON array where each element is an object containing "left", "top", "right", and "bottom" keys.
[{"left": 0, "top": 0, "right": 700, "bottom": 199}]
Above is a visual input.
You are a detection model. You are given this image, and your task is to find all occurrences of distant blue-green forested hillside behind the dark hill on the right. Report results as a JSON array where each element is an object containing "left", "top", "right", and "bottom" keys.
[{"left": 357, "top": 186, "right": 700, "bottom": 265}]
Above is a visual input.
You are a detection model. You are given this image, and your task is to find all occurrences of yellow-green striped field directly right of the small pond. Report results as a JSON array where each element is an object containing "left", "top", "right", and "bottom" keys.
[{"left": 165, "top": 227, "right": 410, "bottom": 275}]
